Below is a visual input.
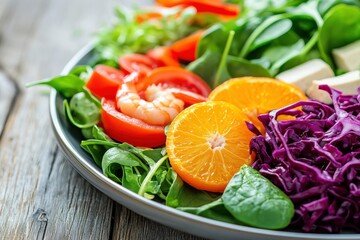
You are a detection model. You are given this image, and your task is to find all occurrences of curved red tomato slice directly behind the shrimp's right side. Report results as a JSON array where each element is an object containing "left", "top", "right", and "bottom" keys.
[{"left": 136, "top": 67, "right": 211, "bottom": 97}]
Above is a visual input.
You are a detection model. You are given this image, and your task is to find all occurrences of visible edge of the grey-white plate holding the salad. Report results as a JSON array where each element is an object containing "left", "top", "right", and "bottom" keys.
[{"left": 50, "top": 44, "right": 360, "bottom": 240}]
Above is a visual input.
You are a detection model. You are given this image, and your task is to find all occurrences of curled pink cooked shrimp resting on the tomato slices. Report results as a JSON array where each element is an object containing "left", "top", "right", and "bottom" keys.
[{"left": 116, "top": 73, "right": 184, "bottom": 125}]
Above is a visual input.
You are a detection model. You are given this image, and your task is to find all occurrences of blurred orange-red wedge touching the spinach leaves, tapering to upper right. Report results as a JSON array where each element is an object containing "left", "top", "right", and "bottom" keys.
[{"left": 171, "top": 30, "right": 204, "bottom": 62}]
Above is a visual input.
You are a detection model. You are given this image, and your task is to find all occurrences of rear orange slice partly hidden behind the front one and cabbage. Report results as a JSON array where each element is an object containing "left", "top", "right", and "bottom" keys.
[{"left": 208, "top": 77, "right": 307, "bottom": 132}]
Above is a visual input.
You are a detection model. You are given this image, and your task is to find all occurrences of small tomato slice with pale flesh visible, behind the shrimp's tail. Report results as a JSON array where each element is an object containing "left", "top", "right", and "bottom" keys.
[{"left": 119, "top": 53, "right": 157, "bottom": 76}]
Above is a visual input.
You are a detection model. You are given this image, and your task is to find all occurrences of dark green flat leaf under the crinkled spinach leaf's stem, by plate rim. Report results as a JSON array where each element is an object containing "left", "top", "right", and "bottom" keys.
[{"left": 177, "top": 198, "right": 243, "bottom": 225}]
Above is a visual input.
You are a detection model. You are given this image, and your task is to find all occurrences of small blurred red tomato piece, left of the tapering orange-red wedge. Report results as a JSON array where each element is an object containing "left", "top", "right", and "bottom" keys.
[{"left": 146, "top": 46, "right": 181, "bottom": 67}]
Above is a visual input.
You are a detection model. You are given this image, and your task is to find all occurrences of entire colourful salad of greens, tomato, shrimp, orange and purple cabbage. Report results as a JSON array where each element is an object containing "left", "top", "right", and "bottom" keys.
[{"left": 30, "top": 0, "right": 360, "bottom": 233}]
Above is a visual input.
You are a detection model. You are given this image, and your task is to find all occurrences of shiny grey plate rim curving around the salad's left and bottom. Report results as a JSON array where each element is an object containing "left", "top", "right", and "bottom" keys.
[{"left": 49, "top": 41, "right": 360, "bottom": 240}]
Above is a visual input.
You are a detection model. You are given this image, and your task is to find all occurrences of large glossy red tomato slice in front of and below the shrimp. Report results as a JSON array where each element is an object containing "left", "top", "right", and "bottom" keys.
[{"left": 101, "top": 99, "right": 166, "bottom": 148}]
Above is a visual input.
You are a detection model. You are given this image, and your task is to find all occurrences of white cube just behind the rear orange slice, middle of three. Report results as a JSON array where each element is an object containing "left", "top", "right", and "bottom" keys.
[{"left": 276, "top": 59, "right": 335, "bottom": 91}]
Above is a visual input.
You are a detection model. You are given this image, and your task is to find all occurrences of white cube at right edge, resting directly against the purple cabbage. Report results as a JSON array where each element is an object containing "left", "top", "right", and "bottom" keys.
[{"left": 306, "top": 71, "right": 360, "bottom": 104}]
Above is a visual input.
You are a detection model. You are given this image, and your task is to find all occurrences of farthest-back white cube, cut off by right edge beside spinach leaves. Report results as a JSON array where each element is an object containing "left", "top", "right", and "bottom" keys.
[{"left": 332, "top": 40, "right": 360, "bottom": 71}]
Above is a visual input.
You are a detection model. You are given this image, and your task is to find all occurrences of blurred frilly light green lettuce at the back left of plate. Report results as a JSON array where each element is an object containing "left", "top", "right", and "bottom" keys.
[{"left": 95, "top": 8, "right": 197, "bottom": 65}]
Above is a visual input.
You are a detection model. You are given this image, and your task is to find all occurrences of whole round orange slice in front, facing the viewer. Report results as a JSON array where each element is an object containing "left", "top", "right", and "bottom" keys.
[{"left": 166, "top": 101, "right": 254, "bottom": 192}]
